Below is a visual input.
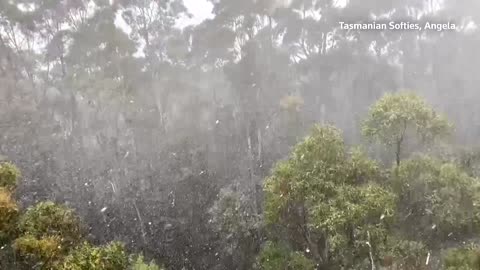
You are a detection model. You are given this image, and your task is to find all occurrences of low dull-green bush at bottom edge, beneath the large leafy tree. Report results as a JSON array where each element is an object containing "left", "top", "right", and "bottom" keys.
[{"left": 257, "top": 242, "right": 315, "bottom": 270}]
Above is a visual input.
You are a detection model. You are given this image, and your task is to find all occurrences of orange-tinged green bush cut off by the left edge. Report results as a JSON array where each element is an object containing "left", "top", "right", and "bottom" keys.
[{"left": 0, "top": 188, "right": 19, "bottom": 243}]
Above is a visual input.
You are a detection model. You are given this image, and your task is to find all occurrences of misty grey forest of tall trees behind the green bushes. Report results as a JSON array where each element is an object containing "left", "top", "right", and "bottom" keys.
[{"left": 0, "top": 0, "right": 480, "bottom": 269}]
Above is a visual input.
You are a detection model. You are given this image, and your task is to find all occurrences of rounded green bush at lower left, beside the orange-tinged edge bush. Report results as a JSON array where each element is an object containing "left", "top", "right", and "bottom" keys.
[{"left": 18, "top": 202, "right": 83, "bottom": 248}]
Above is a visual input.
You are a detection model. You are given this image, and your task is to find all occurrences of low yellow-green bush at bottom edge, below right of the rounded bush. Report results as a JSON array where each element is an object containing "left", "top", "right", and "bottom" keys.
[{"left": 59, "top": 242, "right": 130, "bottom": 270}]
